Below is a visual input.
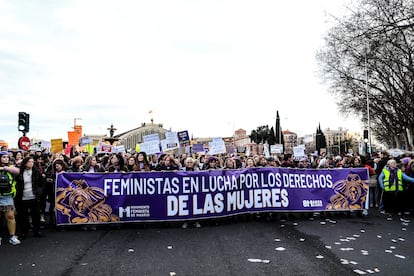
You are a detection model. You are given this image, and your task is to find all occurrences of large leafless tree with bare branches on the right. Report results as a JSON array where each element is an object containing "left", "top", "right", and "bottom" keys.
[{"left": 317, "top": 0, "right": 414, "bottom": 149}]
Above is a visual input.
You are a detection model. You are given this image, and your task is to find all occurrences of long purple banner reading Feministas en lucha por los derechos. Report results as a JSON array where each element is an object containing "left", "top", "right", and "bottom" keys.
[{"left": 56, "top": 168, "right": 369, "bottom": 225}]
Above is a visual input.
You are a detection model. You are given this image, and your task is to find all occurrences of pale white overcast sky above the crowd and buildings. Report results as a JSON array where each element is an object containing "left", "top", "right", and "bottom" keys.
[{"left": 0, "top": 0, "right": 361, "bottom": 147}]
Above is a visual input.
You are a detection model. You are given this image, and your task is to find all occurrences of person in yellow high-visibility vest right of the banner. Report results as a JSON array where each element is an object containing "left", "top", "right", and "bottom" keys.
[{"left": 378, "top": 159, "right": 414, "bottom": 219}]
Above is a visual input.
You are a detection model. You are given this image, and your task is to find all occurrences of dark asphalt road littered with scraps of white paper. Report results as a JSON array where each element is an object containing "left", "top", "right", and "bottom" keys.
[{"left": 0, "top": 210, "right": 414, "bottom": 276}]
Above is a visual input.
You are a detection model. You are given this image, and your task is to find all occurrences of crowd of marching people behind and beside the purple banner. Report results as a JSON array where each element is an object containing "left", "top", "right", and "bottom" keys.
[{"left": 0, "top": 147, "right": 414, "bottom": 245}]
